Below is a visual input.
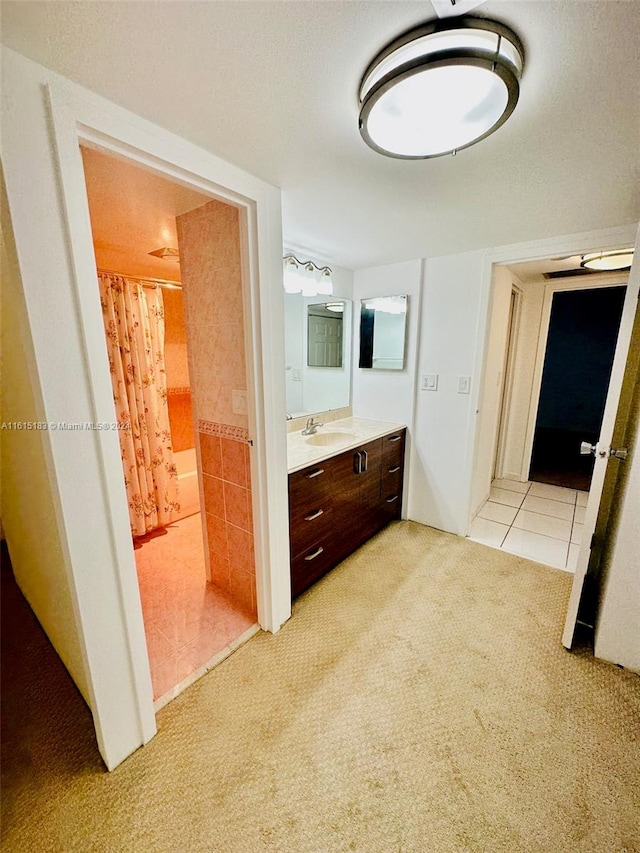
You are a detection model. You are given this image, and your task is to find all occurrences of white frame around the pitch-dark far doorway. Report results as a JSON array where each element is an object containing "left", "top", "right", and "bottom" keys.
[{"left": 520, "top": 272, "right": 629, "bottom": 483}]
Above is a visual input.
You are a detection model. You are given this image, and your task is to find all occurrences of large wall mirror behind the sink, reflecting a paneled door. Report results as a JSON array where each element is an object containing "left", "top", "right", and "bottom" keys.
[{"left": 284, "top": 293, "right": 352, "bottom": 418}]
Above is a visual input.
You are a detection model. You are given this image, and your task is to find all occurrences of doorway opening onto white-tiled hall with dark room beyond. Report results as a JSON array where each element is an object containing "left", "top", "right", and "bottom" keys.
[{"left": 469, "top": 256, "right": 628, "bottom": 572}]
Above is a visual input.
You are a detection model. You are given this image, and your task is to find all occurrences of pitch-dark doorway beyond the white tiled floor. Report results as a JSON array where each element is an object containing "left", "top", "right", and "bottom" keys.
[{"left": 529, "top": 286, "right": 626, "bottom": 491}]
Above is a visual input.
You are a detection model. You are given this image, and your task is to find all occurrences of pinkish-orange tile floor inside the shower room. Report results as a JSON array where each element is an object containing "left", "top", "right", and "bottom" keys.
[{"left": 134, "top": 513, "right": 257, "bottom": 706}]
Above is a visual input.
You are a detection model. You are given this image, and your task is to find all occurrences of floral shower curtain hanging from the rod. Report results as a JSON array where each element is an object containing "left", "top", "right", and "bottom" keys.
[{"left": 98, "top": 273, "right": 180, "bottom": 536}]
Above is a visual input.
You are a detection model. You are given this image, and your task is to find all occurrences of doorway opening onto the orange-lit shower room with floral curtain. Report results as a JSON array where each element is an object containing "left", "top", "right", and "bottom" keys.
[{"left": 81, "top": 145, "right": 257, "bottom": 710}]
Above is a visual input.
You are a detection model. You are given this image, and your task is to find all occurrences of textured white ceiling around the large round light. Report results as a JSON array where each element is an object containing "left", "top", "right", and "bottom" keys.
[{"left": 2, "top": 0, "right": 640, "bottom": 268}]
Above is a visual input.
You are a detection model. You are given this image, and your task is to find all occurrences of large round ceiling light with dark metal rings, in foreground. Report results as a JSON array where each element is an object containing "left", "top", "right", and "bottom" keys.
[{"left": 360, "top": 17, "right": 524, "bottom": 160}]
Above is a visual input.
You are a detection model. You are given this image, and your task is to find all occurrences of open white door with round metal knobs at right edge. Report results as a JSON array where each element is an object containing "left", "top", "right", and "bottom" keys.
[{"left": 562, "top": 230, "right": 640, "bottom": 649}]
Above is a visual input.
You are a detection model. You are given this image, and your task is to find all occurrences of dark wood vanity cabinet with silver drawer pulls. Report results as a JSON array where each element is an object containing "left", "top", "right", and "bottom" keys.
[{"left": 289, "top": 429, "right": 406, "bottom": 598}]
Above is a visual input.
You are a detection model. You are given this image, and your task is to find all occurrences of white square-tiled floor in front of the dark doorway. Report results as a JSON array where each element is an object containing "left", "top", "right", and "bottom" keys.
[{"left": 469, "top": 480, "right": 589, "bottom": 572}]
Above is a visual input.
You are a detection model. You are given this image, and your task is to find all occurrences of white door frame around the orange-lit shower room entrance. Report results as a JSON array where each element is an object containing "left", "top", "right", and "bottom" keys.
[{"left": 46, "top": 75, "right": 291, "bottom": 768}]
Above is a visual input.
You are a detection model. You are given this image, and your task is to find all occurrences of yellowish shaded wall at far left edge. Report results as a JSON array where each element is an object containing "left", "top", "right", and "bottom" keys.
[{"left": 0, "top": 175, "right": 91, "bottom": 705}]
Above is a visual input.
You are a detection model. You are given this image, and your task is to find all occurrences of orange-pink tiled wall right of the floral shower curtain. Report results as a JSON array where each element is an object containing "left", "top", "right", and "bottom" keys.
[{"left": 176, "top": 196, "right": 256, "bottom": 617}]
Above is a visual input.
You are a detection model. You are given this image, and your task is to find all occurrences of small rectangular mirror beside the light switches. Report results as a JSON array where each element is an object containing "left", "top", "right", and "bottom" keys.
[{"left": 359, "top": 296, "right": 408, "bottom": 370}]
